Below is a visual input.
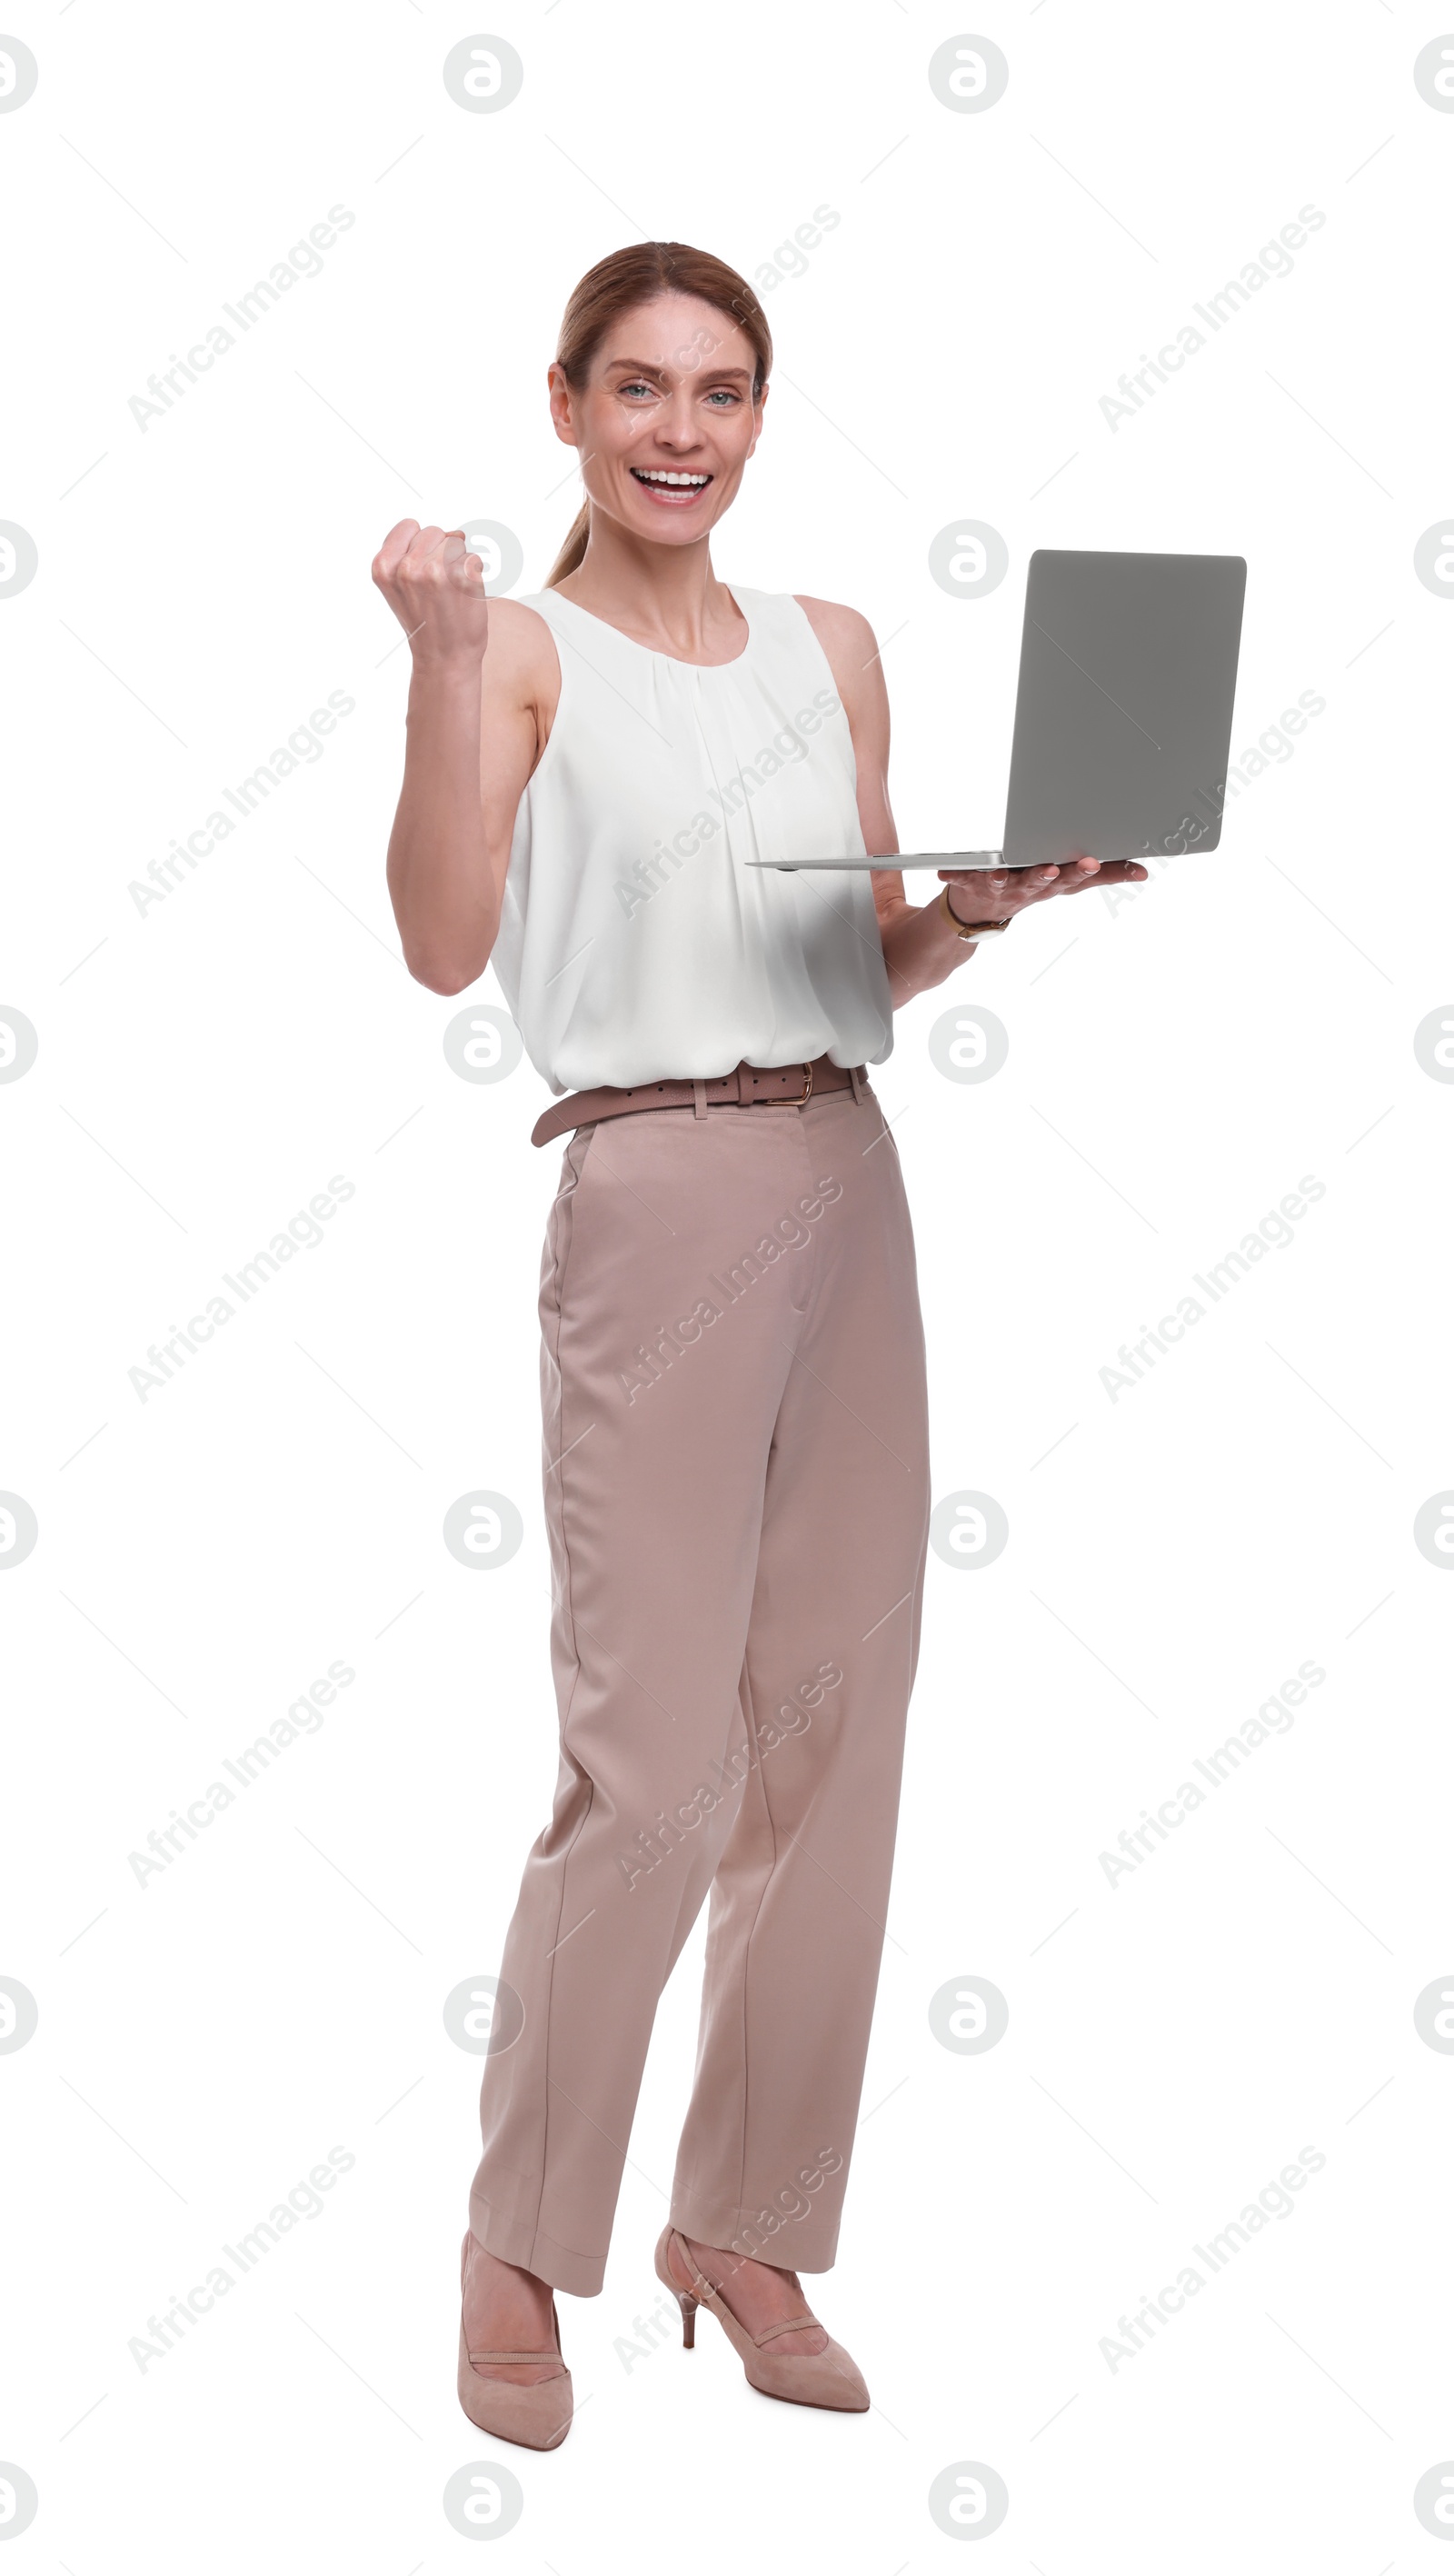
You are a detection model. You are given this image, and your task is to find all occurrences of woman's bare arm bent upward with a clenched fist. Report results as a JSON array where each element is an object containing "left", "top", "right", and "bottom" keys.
[{"left": 373, "top": 518, "right": 559, "bottom": 992}]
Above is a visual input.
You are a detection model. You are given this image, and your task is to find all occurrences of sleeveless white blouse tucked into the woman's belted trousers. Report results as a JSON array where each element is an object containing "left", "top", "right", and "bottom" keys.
[{"left": 494, "top": 582, "right": 893, "bottom": 1093}]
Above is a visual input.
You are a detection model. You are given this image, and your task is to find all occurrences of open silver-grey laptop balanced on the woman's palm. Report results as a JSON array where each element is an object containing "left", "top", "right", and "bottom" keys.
[{"left": 749, "top": 549, "right": 1248, "bottom": 868}]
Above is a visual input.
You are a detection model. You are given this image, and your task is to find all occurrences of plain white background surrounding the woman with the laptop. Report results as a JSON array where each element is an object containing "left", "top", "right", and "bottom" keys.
[{"left": 0, "top": 0, "right": 1454, "bottom": 2576}]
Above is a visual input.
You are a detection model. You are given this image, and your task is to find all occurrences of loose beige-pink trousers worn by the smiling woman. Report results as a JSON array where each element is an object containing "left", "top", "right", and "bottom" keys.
[{"left": 471, "top": 1084, "right": 929, "bottom": 2295}]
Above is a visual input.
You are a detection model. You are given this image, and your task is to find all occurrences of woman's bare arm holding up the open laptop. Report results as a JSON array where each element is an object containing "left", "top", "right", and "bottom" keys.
[{"left": 798, "top": 600, "right": 1145, "bottom": 1010}]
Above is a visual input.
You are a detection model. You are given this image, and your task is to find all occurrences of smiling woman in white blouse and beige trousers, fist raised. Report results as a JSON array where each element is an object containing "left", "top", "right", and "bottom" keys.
[{"left": 373, "top": 242, "right": 1145, "bottom": 2450}]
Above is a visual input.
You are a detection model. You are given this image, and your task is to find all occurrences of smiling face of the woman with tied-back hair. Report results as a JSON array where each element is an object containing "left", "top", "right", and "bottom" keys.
[{"left": 551, "top": 294, "right": 767, "bottom": 546}]
